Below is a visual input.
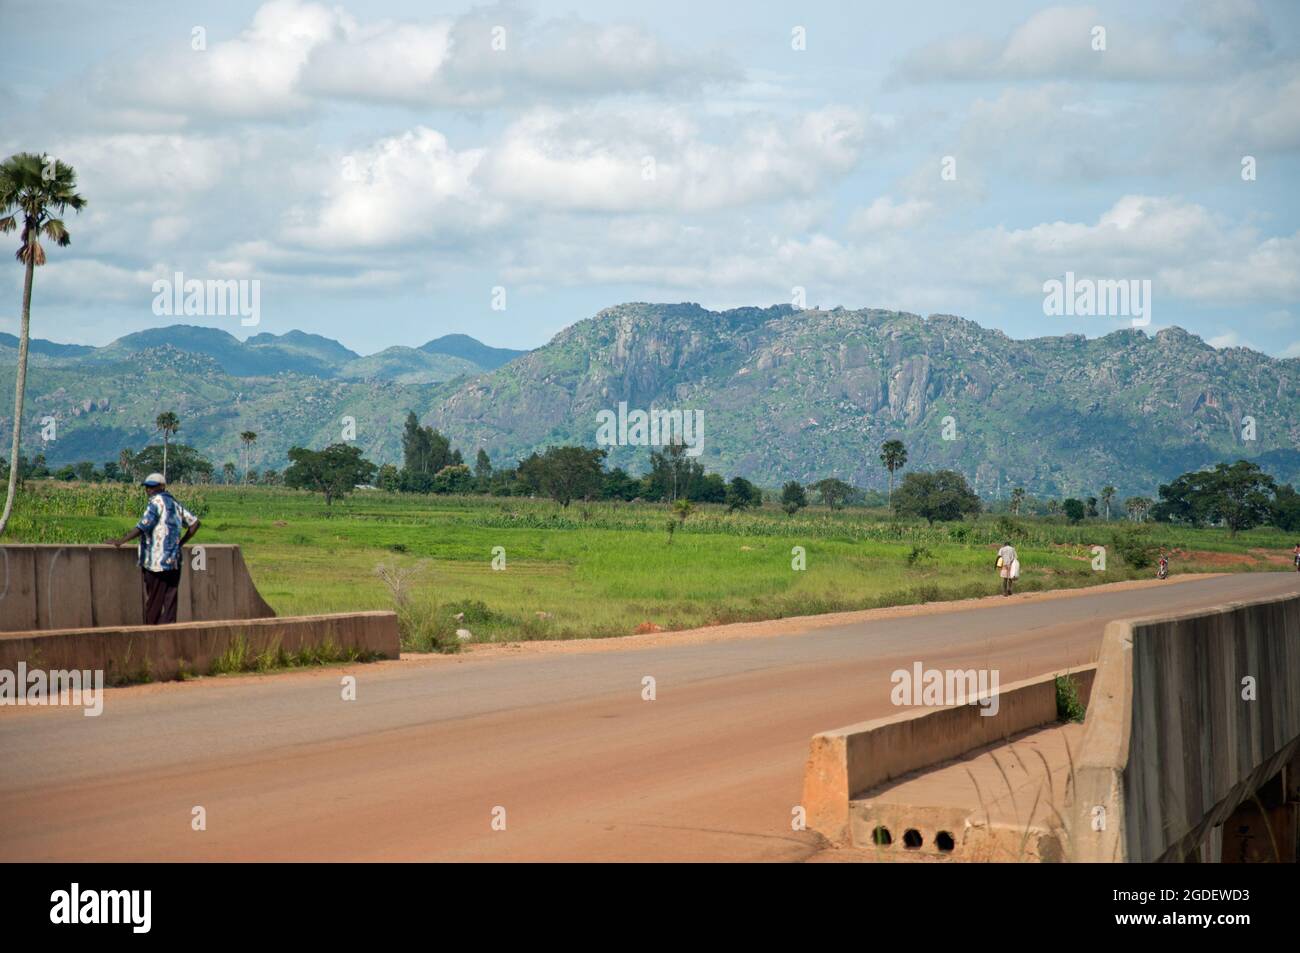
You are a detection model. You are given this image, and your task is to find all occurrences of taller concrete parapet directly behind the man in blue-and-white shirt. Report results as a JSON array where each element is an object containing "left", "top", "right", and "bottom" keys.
[{"left": 0, "top": 543, "right": 276, "bottom": 632}]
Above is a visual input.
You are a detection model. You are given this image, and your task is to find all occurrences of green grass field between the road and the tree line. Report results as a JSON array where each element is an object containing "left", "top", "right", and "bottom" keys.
[{"left": 7, "top": 482, "right": 1295, "bottom": 649}]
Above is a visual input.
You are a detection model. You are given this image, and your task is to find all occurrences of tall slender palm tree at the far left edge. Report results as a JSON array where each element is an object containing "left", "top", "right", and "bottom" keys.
[{"left": 0, "top": 152, "right": 86, "bottom": 534}]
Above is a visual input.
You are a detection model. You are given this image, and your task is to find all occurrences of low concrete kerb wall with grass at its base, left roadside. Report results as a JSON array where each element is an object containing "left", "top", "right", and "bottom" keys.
[{"left": 0, "top": 612, "right": 400, "bottom": 684}]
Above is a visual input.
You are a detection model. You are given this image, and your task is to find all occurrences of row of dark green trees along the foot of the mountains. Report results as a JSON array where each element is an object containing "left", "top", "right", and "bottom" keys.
[{"left": 17, "top": 400, "right": 1300, "bottom": 534}]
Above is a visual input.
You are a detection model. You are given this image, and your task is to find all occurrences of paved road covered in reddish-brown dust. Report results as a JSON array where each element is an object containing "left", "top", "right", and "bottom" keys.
[{"left": 0, "top": 573, "right": 1300, "bottom": 861}]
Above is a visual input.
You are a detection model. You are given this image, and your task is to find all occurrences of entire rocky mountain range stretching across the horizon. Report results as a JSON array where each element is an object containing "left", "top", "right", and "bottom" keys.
[{"left": 0, "top": 303, "right": 1300, "bottom": 497}]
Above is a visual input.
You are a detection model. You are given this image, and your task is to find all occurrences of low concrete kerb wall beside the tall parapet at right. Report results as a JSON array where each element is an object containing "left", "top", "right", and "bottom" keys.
[{"left": 803, "top": 666, "right": 1096, "bottom": 842}]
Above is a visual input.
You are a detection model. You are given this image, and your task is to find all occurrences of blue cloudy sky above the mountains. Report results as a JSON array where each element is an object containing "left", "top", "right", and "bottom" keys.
[{"left": 0, "top": 0, "right": 1300, "bottom": 358}]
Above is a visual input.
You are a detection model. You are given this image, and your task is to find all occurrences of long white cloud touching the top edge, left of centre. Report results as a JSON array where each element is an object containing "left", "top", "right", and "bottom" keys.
[{"left": 85, "top": 0, "right": 741, "bottom": 129}]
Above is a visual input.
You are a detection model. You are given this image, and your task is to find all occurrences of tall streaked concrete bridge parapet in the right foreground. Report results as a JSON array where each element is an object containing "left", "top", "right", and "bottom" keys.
[{"left": 1069, "top": 595, "right": 1300, "bottom": 862}]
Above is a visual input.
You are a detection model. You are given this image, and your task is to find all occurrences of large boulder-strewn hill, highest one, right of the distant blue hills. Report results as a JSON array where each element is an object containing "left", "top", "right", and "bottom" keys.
[{"left": 432, "top": 304, "right": 1300, "bottom": 497}]
